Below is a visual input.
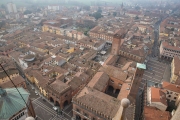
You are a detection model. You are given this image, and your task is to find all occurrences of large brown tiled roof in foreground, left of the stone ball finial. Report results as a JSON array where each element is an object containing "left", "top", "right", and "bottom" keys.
[{"left": 75, "top": 87, "right": 120, "bottom": 118}]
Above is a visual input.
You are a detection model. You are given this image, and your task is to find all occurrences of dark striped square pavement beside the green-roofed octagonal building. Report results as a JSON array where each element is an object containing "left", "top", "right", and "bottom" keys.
[{"left": 32, "top": 96, "right": 72, "bottom": 120}]
